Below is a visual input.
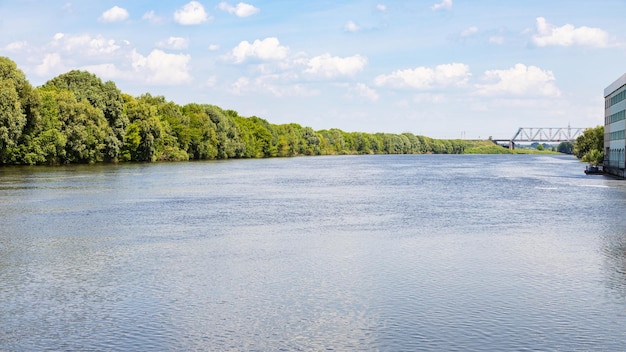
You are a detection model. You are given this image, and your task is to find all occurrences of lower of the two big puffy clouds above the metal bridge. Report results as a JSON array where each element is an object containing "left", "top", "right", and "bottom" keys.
[{"left": 476, "top": 64, "right": 561, "bottom": 97}]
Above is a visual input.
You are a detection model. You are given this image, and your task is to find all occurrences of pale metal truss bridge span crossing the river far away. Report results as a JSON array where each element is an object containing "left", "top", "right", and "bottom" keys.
[{"left": 489, "top": 126, "right": 585, "bottom": 149}]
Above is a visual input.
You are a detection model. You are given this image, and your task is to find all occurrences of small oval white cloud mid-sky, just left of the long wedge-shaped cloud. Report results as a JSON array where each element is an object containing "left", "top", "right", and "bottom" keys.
[{"left": 304, "top": 53, "right": 367, "bottom": 78}]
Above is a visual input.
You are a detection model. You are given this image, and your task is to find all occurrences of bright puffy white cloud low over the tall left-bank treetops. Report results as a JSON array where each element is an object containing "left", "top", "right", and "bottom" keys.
[{"left": 131, "top": 49, "right": 192, "bottom": 85}]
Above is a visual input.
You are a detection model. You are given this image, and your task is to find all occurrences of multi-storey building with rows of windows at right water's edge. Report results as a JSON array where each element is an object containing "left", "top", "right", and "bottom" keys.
[{"left": 604, "top": 74, "right": 626, "bottom": 177}]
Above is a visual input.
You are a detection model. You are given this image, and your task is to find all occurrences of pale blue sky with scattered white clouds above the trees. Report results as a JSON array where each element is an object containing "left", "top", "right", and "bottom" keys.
[{"left": 0, "top": 0, "right": 626, "bottom": 139}]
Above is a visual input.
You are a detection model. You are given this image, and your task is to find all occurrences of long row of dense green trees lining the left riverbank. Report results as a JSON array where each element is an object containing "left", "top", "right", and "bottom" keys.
[{"left": 0, "top": 57, "right": 602, "bottom": 165}]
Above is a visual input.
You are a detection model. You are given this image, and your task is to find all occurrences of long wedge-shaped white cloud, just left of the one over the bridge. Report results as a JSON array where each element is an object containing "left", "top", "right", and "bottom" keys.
[{"left": 374, "top": 63, "right": 471, "bottom": 89}]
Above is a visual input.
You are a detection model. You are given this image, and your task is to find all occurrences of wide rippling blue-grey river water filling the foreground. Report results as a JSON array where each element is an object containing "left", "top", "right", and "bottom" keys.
[{"left": 0, "top": 155, "right": 626, "bottom": 351}]
